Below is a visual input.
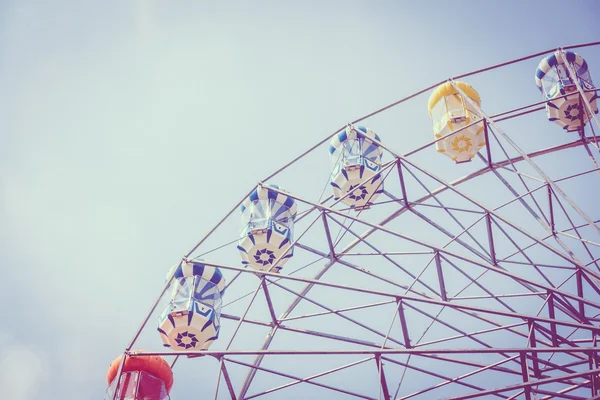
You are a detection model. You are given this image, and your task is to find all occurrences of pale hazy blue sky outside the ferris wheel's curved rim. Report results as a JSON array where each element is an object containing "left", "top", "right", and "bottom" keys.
[{"left": 0, "top": 0, "right": 600, "bottom": 400}]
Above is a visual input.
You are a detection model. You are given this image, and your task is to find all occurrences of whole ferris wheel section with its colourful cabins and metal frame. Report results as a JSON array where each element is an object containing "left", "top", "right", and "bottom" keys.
[{"left": 106, "top": 42, "right": 600, "bottom": 400}]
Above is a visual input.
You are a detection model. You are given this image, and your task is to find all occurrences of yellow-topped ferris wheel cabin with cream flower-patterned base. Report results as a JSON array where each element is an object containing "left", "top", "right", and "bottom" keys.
[{"left": 428, "top": 81, "right": 485, "bottom": 163}]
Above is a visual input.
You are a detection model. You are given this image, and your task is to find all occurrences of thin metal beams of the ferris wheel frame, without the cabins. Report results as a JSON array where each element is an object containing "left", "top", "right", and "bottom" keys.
[{"left": 113, "top": 42, "right": 600, "bottom": 400}]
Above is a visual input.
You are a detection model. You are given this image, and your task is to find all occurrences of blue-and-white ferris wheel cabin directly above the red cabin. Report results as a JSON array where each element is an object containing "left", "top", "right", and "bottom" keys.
[{"left": 158, "top": 262, "right": 225, "bottom": 351}]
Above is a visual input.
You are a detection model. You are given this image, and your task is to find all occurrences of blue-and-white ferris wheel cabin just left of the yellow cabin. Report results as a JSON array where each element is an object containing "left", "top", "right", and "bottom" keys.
[{"left": 329, "top": 125, "right": 383, "bottom": 210}]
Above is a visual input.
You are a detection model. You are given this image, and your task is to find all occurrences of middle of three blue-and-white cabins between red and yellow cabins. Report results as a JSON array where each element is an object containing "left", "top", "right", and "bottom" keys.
[{"left": 238, "top": 185, "right": 297, "bottom": 272}]
